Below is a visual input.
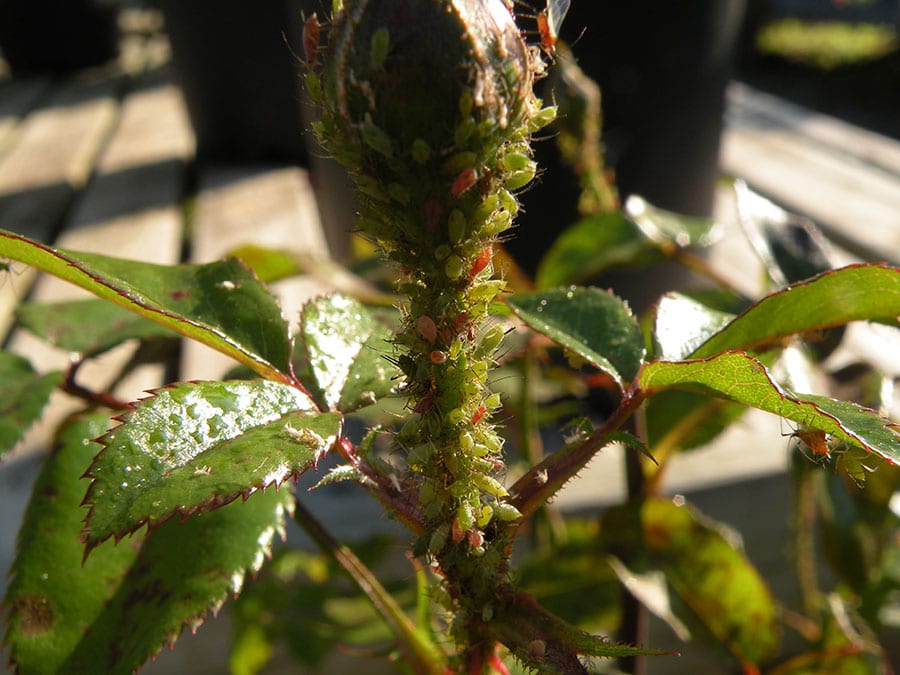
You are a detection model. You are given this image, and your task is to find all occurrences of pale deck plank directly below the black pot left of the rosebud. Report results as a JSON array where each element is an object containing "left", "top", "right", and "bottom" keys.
[{"left": 181, "top": 166, "right": 328, "bottom": 379}]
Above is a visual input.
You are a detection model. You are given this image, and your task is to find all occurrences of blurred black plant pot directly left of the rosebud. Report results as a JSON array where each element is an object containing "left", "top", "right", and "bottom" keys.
[{"left": 160, "top": 0, "right": 306, "bottom": 164}]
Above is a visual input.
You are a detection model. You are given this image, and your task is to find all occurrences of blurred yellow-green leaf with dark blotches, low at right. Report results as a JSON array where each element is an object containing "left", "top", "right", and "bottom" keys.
[{"left": 641, "top": 499, "right": 779, "bottom": 665}]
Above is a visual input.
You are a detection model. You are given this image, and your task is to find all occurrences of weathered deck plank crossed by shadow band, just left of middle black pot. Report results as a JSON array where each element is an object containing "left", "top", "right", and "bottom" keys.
[{"left": 9, "top": 76, "right": 192, "bottom": 462}]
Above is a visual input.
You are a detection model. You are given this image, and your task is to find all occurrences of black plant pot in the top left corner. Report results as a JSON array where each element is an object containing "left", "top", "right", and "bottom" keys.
[{"left": 0, "top": 0, "right": 119, "bottom": 76}]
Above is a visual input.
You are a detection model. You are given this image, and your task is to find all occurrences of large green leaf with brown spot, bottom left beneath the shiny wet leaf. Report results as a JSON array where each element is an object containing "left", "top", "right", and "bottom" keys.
[{"left": 4, "top": 415, "right": 293, "bottom": 674}]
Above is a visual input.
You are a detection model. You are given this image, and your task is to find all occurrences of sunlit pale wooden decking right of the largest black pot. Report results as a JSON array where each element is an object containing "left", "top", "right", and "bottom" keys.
[{"left": 721, "top": 86, "right": 900, "bottom": 264}]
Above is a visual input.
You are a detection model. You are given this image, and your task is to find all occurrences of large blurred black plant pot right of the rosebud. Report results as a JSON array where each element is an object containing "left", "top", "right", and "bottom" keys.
[{"left": 511, "top": 0, "right": 746, "bottom": 282}]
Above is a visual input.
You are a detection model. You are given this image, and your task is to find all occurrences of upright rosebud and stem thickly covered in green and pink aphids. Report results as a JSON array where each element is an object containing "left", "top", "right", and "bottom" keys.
[{"left": 307, "top": 0, "right": 554, "bottom": 664}]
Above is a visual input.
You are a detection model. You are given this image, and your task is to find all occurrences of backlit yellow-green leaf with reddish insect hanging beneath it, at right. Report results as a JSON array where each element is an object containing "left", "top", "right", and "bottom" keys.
[{"left": 638, "top": 352, "right": 900, "bottom": 464}]
